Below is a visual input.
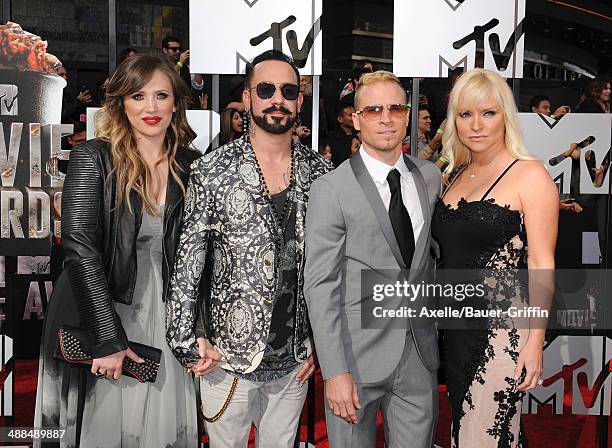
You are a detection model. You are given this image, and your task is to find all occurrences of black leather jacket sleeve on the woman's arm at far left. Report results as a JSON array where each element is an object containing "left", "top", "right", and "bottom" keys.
[{"left": 62, "top": 142, "right": 127, "bottom": 358}]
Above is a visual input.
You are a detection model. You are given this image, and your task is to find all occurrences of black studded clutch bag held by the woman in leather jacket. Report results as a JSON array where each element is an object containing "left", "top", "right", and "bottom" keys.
[{"left": 55, "top": 325, "right": 161, "bottom": 383}]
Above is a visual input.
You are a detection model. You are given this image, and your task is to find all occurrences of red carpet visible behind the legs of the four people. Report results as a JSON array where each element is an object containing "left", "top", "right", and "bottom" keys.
[{"left": 0, "top": 360, "right": 612, "bottom": 448}]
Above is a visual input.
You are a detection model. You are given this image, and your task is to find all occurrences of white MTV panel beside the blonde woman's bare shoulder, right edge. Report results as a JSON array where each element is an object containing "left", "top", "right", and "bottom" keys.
[{"left": 519, "top": 113, "right": 612, "bottom": 194}]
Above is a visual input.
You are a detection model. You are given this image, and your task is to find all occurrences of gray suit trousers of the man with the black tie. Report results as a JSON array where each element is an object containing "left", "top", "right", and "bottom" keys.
[{"left": 325, "top": 333, "right": 438, "bottom": 448}]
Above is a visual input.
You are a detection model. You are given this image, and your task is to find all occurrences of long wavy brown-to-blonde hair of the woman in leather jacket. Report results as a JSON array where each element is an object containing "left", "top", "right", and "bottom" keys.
[{"left": 95, "top": 54, "right": 196, "bottom": 215}]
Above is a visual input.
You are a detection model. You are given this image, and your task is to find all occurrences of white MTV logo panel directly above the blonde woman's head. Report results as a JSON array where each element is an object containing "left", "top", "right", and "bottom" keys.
[{"left": 393, "top": 0, "right": 525, "bottom": 78}]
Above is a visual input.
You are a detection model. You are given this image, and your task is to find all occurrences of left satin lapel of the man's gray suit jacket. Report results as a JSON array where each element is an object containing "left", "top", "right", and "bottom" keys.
[{"left": 349, "top": 152, "right": 406, "bottom": 269}]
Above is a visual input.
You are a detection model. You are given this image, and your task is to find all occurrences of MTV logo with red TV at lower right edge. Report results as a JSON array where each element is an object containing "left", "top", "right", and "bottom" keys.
[{"left": 522, "top": 336, "right": 612, "bottom": 415}]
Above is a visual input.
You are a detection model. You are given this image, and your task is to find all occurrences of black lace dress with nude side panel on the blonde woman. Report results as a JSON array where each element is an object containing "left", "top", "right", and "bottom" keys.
[{"left": 432, "top": 161, "right": 528, "bottom": 448}]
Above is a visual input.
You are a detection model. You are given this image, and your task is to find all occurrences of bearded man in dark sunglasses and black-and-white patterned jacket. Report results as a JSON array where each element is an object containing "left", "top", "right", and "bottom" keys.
[{"left": 166, "top": 50, "right": 331, "bottom": 448}]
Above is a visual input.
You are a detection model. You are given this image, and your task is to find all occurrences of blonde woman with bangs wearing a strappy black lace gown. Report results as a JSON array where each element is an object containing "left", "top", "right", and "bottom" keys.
[{"left": 432, "top": 69, "right": 559, "bottom": 448}]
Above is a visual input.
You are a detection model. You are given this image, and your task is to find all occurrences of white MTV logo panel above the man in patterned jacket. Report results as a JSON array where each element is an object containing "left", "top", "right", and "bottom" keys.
[{"left": 189, "top": 0, "right": 323, "bottom": 75}]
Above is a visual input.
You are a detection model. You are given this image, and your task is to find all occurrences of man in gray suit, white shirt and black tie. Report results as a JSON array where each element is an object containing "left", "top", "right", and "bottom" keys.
[{"left": 304, "top": 71, "right": 440, "bottom": 448}]
